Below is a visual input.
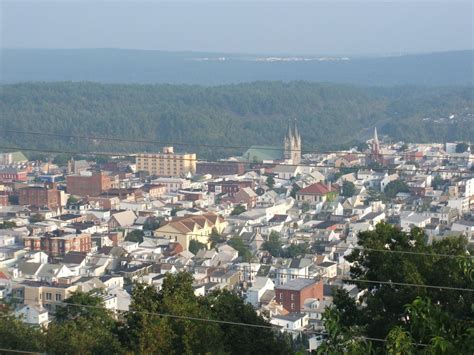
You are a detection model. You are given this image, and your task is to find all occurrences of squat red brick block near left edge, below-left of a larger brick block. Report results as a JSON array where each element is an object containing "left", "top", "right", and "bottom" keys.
[{"left": 18, "top": 184, "right": 61, "bottom": 210}]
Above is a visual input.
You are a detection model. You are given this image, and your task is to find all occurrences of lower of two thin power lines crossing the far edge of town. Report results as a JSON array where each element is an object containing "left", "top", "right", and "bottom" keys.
[{"left": 0, "top": 146, "right": 474, "bottom": 175}]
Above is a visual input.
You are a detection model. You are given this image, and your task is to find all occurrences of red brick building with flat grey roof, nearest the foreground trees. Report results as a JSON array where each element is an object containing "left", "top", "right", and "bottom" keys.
[{"left": 275, "top": 279, "right": 324, "bottom": 312}]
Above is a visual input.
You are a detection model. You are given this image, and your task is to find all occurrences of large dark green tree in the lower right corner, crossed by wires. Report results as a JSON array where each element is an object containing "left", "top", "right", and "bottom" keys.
[{"left": 321, "top": 224, "right": 474, "bottom": 354}]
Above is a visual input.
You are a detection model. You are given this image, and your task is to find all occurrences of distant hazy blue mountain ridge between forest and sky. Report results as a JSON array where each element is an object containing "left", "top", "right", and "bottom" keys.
[{"left": 0, "top": 49, "right": 474, "bottom": 86}]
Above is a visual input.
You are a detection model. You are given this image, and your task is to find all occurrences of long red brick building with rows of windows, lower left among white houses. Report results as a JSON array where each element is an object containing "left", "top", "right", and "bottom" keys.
[{"left": 23, "top": 233, "right": 92, "bottom": 256}]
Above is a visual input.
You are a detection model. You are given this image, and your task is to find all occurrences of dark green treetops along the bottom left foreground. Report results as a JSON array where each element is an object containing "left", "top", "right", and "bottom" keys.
[{"left": 0, "top": 272, "right": 290, "bottom": 354}]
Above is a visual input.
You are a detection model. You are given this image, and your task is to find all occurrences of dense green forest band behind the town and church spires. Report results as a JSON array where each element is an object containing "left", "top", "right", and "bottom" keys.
[{"left": 0, "top": 82, "right": 474, "bottom": 158}]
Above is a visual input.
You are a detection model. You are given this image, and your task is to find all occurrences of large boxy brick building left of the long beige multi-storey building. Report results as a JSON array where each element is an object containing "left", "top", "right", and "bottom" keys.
[{"left": 66, "top": 172, "right": 113, "bottom": 196}]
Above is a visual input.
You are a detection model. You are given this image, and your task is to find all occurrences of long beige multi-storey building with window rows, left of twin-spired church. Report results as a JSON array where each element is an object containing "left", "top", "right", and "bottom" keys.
[{"left": 136, "top": 147, "right": 196, "bottom": 176}]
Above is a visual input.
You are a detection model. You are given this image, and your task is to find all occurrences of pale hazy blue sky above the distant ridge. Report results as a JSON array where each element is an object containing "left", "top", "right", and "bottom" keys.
[{"left": 0, "top": 0, "right": 474, "bottom": 55}]
